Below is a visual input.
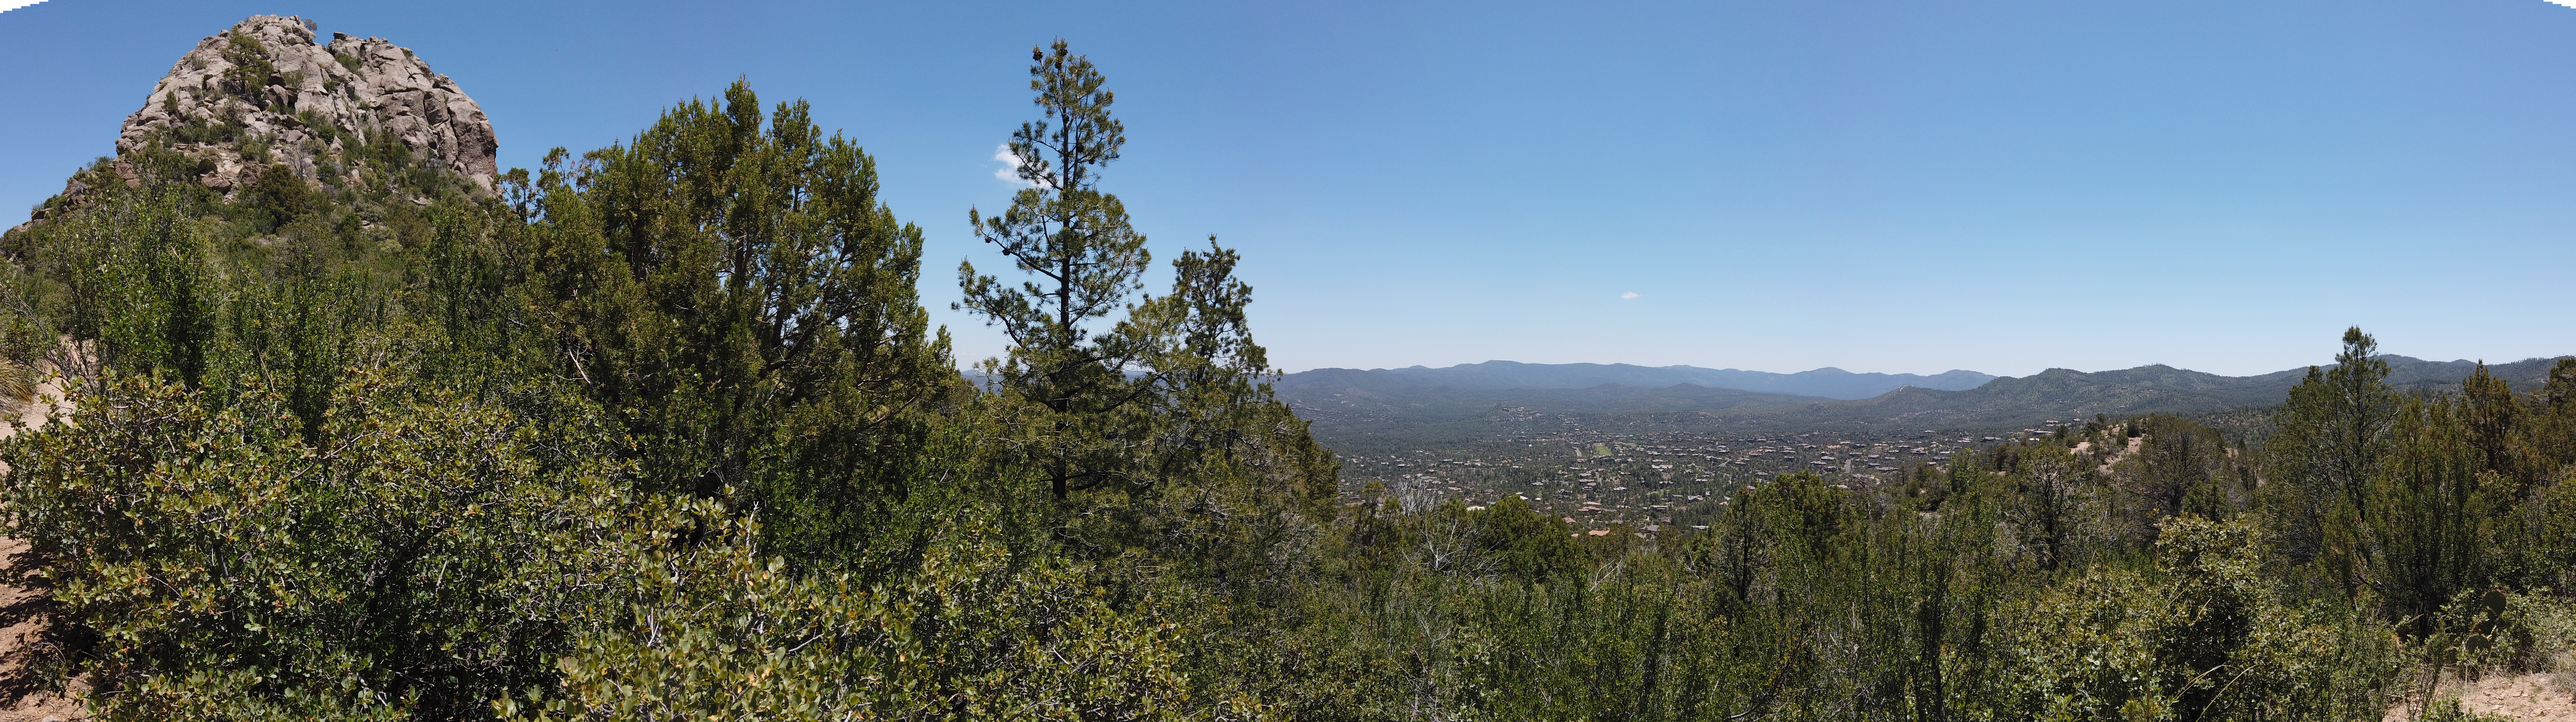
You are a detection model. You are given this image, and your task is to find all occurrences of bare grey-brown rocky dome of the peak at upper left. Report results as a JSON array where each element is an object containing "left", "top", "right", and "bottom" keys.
[{"left": 111, "top": 16, "right": 500, "bottom": 193}]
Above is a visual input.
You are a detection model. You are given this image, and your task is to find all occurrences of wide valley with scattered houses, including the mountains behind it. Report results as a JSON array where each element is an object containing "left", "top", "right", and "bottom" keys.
[{"left": 1298, "top": 356, "right": 2555, "bottom": 534}]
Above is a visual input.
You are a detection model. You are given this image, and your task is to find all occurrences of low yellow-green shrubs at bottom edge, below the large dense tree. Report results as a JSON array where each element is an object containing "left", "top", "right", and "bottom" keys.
[{"left": 515, "top": 503, "right": 1198, "bottom": 719}]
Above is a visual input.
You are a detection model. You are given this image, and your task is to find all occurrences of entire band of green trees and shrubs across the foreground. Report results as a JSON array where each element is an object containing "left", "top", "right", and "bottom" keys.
[{"left": 0, "top": 41, "right": 2576, "bottom": 719}]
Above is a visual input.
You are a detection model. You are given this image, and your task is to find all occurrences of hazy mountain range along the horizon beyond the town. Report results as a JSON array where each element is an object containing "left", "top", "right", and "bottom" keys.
[{"left": 1275, "top": 356, "right": 2555, "bottom": 438}]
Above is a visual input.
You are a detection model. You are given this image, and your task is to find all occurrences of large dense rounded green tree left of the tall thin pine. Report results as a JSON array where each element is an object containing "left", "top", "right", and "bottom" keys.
[{"left": 543, "top": 82, "right": 958, "bottom": 557}]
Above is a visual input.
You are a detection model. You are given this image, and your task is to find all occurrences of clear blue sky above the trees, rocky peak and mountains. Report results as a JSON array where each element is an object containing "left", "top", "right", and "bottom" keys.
[{"left": 0, "top": 0, "right": 2576, "bottom": 374}]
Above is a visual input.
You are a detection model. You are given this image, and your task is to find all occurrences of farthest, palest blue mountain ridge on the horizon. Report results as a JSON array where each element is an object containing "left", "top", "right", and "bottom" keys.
[{"left": 1280, "top": 361, "right": 1994, "bottom": 400}]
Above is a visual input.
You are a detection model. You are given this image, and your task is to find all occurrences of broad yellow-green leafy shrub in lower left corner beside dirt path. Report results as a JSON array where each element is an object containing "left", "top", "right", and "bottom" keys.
[{"left": 0, "top": 348, "right": 631, "bottom": 719}]
